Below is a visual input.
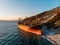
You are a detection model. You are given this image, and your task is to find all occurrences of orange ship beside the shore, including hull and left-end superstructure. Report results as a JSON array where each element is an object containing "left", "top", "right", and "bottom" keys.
[{"left": 17, "top": 18, "right": 42, "bottom": 36}]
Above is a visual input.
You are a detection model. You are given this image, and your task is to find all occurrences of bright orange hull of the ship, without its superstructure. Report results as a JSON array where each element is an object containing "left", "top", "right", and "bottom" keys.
[{"left": 18, "top": 24, "right": 42, "bottom": 35}]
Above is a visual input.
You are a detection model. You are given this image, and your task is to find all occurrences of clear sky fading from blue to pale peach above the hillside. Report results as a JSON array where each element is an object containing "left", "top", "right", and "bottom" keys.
[{"left": 0, "top": 0, "right": 60, "bottom": 20}]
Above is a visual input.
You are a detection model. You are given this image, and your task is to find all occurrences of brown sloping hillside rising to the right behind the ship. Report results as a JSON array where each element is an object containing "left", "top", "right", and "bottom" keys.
[{"left": 24, "top": 6, "right": 60, "bottom": 27}]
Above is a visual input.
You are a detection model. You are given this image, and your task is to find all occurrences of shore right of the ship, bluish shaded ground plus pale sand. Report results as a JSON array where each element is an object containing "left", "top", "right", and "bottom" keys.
[{"left": 42, "top": 26, "right": 60, "bottom": 45}]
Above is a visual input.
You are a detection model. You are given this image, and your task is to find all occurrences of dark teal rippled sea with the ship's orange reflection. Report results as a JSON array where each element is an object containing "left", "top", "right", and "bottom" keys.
[{"left": 0, "top": 21, "right": 51, "bottom": 45}]
